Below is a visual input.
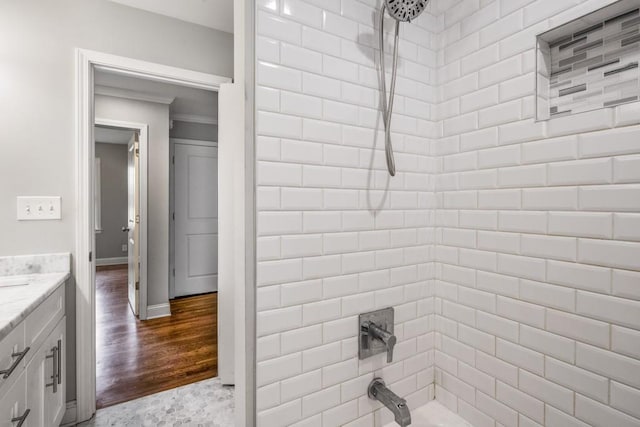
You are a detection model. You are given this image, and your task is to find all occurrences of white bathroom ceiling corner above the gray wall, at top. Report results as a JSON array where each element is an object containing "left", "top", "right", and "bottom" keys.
[{"left": 111, "top": 0, "right": 233, "bottom": 33}]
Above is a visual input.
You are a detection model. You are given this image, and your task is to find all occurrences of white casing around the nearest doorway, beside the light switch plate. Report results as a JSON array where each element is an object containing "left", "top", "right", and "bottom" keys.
[{"left": 74, "top": 48, "right": 235, "bottom": 422}]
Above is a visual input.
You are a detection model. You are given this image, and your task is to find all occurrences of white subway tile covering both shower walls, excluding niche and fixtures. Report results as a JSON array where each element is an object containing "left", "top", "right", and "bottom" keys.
[{"left": 256, "top": 0, "right": 640, "bottom": 427}]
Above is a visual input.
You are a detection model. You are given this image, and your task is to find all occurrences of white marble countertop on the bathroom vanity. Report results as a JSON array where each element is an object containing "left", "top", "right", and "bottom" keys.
[{"left": 0, "top": 254, "right": 71, "bottom": 340}]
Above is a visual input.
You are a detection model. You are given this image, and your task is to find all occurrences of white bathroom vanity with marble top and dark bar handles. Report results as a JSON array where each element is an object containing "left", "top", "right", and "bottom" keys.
[{"left": 0, "top": 254, "right": 70, "bottom": 427}]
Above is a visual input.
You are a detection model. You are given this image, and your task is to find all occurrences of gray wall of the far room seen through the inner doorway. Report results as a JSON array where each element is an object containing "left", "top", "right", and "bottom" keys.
[{"left": 96, "top": 143, "right": 128, "bottom": 259}]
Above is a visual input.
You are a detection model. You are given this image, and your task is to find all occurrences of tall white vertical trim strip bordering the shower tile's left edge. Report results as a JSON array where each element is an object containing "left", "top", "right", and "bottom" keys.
[{"left": 235, "top": 0, "right": 258, "bottom": 427}]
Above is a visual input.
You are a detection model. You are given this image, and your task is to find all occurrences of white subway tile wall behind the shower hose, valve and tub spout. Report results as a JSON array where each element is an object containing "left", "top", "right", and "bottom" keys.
[{"left": 256, "top": 0, "right": 438, "bottom": 427}]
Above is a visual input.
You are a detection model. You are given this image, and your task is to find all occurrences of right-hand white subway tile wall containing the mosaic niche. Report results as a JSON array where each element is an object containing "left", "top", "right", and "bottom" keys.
[{"left": 430, "top": 0, "right": 640, "bottom": 427}]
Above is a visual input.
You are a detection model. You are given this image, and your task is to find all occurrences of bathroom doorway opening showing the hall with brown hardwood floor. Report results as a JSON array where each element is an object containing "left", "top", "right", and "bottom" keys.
[{"left": 93, "top": 66, "right": 233, "bottom": 412}]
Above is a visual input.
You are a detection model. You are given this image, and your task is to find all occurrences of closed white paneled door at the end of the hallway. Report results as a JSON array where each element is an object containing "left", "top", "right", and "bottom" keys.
[{"left": 174, "top": 144, "right": 218, "bottom": 297}]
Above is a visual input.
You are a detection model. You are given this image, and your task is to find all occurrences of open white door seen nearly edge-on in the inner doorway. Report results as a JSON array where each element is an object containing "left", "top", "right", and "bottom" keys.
[{"left": 122, "top": 132, "right": 140, "bottom": 316}]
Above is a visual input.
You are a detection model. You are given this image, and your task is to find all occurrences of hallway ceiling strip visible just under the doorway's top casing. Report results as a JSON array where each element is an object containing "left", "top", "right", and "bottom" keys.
[{"left": 95, "top": 70, "right": 218, "bottom": 121}]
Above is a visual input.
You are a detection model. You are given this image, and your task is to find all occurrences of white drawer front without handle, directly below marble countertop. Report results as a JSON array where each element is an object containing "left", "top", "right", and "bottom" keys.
[{"left": 24, "top": 283, "right": 65, "bottom": 368}]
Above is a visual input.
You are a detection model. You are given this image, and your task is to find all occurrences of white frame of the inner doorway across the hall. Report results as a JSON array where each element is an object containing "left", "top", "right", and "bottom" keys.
[{"left": 91, "top": 117, "right": 149, "bottom": 320}]
